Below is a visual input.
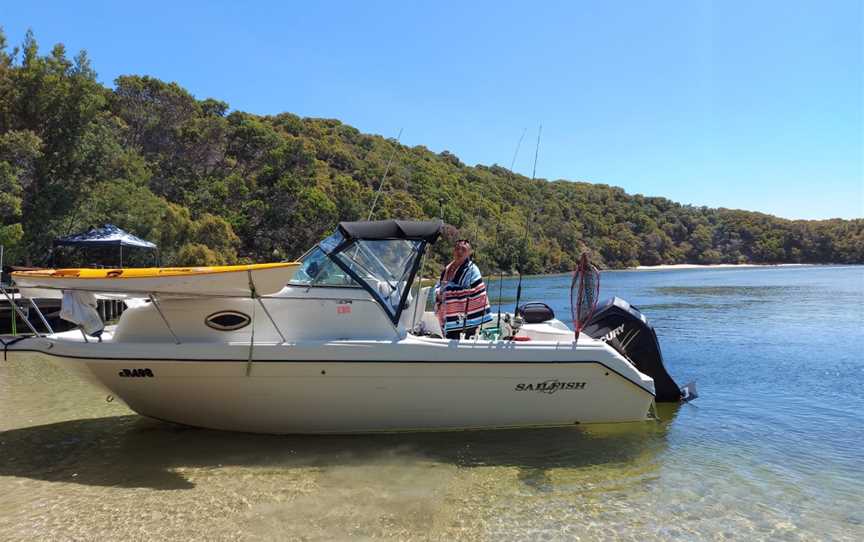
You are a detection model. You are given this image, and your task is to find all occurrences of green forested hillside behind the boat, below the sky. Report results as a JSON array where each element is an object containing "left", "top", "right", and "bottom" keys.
[{"left": 0, "top": 30, "right": 864, "bottom": 272}]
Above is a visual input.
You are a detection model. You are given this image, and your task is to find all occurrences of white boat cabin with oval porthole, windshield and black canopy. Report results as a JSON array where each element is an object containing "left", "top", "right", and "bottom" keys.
[{"left": 33, "top": 220, "right": 572, "bottom": 344}]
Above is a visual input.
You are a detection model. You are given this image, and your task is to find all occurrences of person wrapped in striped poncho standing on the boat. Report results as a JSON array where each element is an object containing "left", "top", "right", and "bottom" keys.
[{"left": 435, "top": 239, "right": 492, "bottom": 339}]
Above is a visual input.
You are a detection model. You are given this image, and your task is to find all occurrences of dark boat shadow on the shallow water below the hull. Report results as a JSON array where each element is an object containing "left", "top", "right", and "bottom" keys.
[{"left": 0, "top": 405, "right": 678, "bottom": 489}]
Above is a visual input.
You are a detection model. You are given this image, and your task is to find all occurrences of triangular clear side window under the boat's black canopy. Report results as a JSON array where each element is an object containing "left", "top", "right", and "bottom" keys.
[{"left": 332, "top": 239, "right": 423, "bottom": 320}]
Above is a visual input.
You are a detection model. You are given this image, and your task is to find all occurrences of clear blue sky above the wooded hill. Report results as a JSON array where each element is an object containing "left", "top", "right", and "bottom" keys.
[{"left": 0, "top": 0, "right": 864, "bottom": 219}]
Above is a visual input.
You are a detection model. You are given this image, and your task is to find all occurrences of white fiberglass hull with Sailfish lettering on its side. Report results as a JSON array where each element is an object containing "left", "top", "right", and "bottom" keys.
[{"left": 8, "top": 339, "right": 654, "bottom": 433}]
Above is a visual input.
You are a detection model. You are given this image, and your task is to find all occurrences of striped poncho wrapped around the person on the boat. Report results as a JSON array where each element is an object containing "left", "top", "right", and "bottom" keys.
[{"left": 435, "top": 258, "right": 492, "bottom": 335}]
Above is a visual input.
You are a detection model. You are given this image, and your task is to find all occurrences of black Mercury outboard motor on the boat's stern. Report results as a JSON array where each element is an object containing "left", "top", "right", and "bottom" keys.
[{"left": 582, "top": 297, "right": 683, "bottom": 403}]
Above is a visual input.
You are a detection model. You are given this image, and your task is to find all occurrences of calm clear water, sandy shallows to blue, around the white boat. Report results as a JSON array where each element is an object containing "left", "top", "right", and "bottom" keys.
[{"left": 0, "top": 267, "right": 864, "bottom": 541}]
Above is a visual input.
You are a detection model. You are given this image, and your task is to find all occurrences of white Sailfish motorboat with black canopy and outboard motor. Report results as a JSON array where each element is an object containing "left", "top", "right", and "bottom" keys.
[{"left": 4, "top": 220, "right": 681, "bottom": 433}]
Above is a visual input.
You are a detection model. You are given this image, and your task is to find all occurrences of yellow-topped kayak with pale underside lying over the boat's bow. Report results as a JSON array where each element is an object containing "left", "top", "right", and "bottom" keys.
[{"left": 12, "top": 262, "right": 300, "bottom": 296}]
